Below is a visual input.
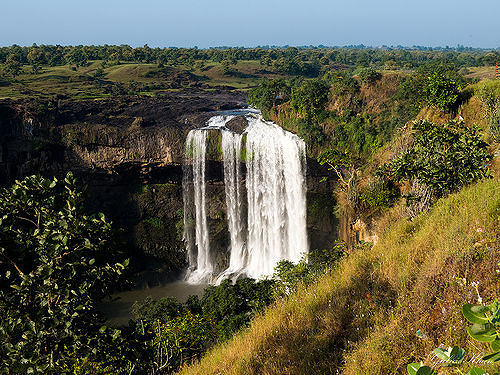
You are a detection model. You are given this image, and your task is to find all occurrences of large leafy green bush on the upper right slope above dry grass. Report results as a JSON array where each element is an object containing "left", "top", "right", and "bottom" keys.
[{"left": 379, "top": 121, "right": 491, "bottom": 197}]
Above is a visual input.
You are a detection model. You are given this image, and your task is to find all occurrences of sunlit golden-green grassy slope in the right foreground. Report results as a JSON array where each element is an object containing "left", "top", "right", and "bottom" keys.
[{"left": 182, "top": 179, "right": 500, "bottom": 374}]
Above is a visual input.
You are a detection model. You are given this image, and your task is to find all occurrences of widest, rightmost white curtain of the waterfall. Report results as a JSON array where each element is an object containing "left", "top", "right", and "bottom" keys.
[{"left": 246, "top": 117, "right": 308, "bottom": 278}]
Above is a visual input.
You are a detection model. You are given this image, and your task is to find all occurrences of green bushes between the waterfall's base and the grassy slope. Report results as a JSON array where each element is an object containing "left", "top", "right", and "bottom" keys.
[{"left": 128, "top": 242, "right": 345, "bottom": 372}]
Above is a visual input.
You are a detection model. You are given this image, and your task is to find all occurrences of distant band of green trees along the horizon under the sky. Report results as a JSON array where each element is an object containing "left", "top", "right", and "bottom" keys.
[{"left": 0, "top": 44, "right": 500, "bottom": 76}]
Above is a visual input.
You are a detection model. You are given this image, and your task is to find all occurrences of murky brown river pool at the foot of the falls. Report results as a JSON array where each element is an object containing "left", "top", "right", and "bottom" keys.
[{"left": 98, "top": 281, "right": 208, "bottom": 326}]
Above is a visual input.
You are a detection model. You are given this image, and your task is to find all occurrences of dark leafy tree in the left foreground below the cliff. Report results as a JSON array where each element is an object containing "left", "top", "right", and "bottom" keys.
[{"left": 0, "top": 173, "right": 128, "bottom": 374}]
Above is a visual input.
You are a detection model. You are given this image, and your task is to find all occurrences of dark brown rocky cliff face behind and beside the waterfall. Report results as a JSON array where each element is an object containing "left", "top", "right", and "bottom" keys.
[{"left": 0, "top": 91, "right": 337, "bottom": 281}]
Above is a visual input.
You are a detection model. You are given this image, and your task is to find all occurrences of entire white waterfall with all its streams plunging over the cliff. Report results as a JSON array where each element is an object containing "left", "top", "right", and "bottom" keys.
[{"left": 183, "top": 114, "right": 308, "bottom": 283}]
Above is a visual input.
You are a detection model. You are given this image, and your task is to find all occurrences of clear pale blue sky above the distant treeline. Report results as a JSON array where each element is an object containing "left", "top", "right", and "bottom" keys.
[{"left": 0, "top": 0, "right": 500, "bottom": 48}]
